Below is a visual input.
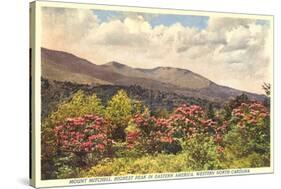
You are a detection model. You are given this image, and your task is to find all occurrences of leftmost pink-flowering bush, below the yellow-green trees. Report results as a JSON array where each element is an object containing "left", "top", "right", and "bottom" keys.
[{"left": 54, "top": 115, "right": 112, "bottom": 166}]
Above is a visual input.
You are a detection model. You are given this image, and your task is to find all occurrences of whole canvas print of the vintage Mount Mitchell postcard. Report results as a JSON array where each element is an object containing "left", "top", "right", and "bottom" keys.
[{"left": 30, "top": 1, "right": 273, "bottom": 187}]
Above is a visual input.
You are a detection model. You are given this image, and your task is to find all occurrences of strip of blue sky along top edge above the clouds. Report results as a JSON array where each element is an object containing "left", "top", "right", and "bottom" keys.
[{"left": 93, "top": 10, "right": 209, "bottom": 30}]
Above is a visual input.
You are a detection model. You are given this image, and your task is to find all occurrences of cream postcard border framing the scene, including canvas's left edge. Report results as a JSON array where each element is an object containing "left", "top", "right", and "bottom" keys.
[{"left": 30, "top": 1, "right": 274, "bottom": 187}]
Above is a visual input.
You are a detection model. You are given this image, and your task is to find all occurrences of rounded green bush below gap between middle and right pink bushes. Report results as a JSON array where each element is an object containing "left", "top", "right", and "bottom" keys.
[{"left": 183, "top": 134, "right": 222, "bottom": 171}]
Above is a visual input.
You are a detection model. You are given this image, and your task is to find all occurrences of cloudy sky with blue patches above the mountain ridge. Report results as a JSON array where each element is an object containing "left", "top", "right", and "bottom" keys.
[{"left": 42, "top": 7, "right": 271, "bottom": 93}]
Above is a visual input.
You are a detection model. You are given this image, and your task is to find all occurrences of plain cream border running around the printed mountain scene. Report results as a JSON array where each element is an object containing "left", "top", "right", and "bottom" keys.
[{"left": 33, "top": 1, "right": 274, "bottom": 187}]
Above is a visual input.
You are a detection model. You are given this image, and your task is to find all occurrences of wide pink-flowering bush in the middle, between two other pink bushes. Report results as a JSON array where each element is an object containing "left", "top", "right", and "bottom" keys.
[{"left": 130, "top": 105, "right": 224, "bottom": 153}]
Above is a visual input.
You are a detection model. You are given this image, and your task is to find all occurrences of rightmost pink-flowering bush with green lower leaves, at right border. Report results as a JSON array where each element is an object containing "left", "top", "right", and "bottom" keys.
[{"left": 224, "top": 102, "right": 270, "bottom": 166}]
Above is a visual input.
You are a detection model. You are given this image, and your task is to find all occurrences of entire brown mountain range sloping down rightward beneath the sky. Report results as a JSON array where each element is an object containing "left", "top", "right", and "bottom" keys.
[{"left": 41, "top": 48, "right": 264, "bottom": 102}]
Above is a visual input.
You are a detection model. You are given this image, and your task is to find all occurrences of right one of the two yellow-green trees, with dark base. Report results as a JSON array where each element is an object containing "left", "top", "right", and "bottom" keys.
[{"left": 105, "top": 90, "right": 133, "bottom": 141}]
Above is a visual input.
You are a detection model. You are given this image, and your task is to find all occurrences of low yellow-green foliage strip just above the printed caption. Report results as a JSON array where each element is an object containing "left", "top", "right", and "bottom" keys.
[{"left": 80, "top": 154, "right": 190, "bottom": 177}]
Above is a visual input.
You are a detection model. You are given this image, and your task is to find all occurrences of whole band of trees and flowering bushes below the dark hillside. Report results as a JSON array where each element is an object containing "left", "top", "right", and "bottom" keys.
[{"left": 41, "top": 85, "right": 270, "bottom": 179}]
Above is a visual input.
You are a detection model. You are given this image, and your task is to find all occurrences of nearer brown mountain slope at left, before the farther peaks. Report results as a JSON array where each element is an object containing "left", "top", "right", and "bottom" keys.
[{"left": 41, "top": 48, "right": 180, "bottom": 91}]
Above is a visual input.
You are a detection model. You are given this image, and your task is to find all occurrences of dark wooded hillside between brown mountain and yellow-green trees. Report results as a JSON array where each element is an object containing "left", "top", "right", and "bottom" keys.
[{"left": 41, "top": 79, "right": 214, "bottom": 118}]
